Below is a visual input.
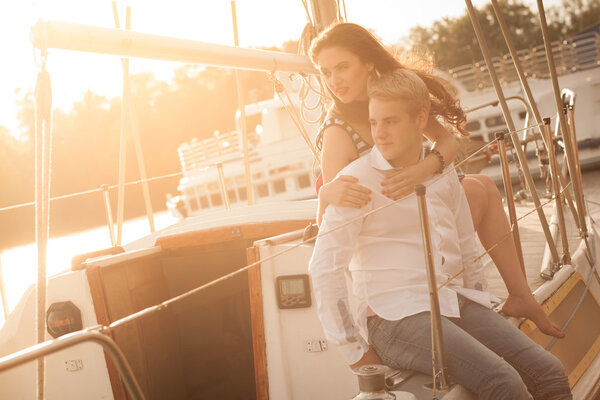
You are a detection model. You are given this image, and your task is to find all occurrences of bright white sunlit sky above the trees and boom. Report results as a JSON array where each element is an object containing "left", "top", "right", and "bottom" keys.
[{"left": 0, "top": 0, "right": 558, "bottom": 137}]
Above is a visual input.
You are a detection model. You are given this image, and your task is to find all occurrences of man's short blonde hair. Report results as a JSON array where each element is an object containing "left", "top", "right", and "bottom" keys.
[{"left": 367, "top": 68, "right": 431, "bottom": 116}]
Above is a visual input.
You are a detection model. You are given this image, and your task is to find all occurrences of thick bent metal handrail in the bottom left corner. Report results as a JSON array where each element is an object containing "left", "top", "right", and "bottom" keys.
[{"left": 0, "top": 325, "right": 145, "bottom": 400}]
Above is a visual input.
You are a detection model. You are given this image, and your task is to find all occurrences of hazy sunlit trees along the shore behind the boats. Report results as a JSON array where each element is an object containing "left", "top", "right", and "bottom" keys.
[{"left": 0, "top": 0, "right": 600, "bottom": 249}]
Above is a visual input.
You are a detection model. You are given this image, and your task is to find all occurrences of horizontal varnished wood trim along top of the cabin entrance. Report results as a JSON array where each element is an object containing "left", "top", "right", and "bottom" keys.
[{"left": 155, "top": 219, "right": 314, "bottom": 249}]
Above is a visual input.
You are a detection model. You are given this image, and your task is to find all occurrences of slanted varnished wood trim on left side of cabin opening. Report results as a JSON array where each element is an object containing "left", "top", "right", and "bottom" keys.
[{"left": 85, "top": 266, "right": 127, "bottom": 400}]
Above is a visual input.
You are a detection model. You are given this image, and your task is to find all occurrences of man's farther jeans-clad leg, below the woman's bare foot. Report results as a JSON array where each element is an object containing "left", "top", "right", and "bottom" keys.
[{"left": 454, "top": 296, "right": 573, "bottom": 400}]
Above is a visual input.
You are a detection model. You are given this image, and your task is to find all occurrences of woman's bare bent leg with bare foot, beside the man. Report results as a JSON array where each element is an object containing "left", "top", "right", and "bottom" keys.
[{"left": 462, "top": 175, "right": 564, "bottom": 337}]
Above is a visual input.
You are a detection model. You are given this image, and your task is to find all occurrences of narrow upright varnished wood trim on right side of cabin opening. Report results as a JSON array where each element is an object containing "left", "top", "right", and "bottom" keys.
[{"left": 246, "top": 247, "right": 269, "bottom": 400}]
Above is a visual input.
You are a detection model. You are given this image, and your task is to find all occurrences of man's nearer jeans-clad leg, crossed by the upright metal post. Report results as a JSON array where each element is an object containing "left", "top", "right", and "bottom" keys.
[{"left": 368, "top": 312, "right": 531, "bottom": 400}]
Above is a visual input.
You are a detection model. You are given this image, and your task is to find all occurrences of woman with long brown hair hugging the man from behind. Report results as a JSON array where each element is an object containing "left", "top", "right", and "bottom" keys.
[{"left": 310, "top": 23, "right": 564, "bottom": 338}]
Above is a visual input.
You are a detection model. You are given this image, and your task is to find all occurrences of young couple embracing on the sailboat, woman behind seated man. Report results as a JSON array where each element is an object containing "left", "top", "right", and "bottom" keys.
[{"left": 309, "top": 23, "right": 572, "bottom": 399}]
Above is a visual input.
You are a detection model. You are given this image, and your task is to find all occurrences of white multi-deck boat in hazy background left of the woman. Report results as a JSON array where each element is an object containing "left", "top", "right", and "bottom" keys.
[{"left": 167, "top": 78, "right": 319, "bottom": 217}]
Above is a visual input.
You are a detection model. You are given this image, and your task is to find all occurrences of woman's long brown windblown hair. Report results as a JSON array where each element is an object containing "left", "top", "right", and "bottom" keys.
[{"left": 309, "top": 23, "right": 468, "bottom": 136}]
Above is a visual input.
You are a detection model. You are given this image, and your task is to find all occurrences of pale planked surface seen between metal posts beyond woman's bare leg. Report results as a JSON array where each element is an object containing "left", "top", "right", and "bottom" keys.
[{"left": 480, "top": 198, "right": 580, "bottom": 300}]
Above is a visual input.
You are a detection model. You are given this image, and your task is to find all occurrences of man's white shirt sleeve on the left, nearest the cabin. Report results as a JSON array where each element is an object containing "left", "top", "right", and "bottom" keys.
[{"left": 308, "top": 205, "right": 369, "bottom": 365}]
